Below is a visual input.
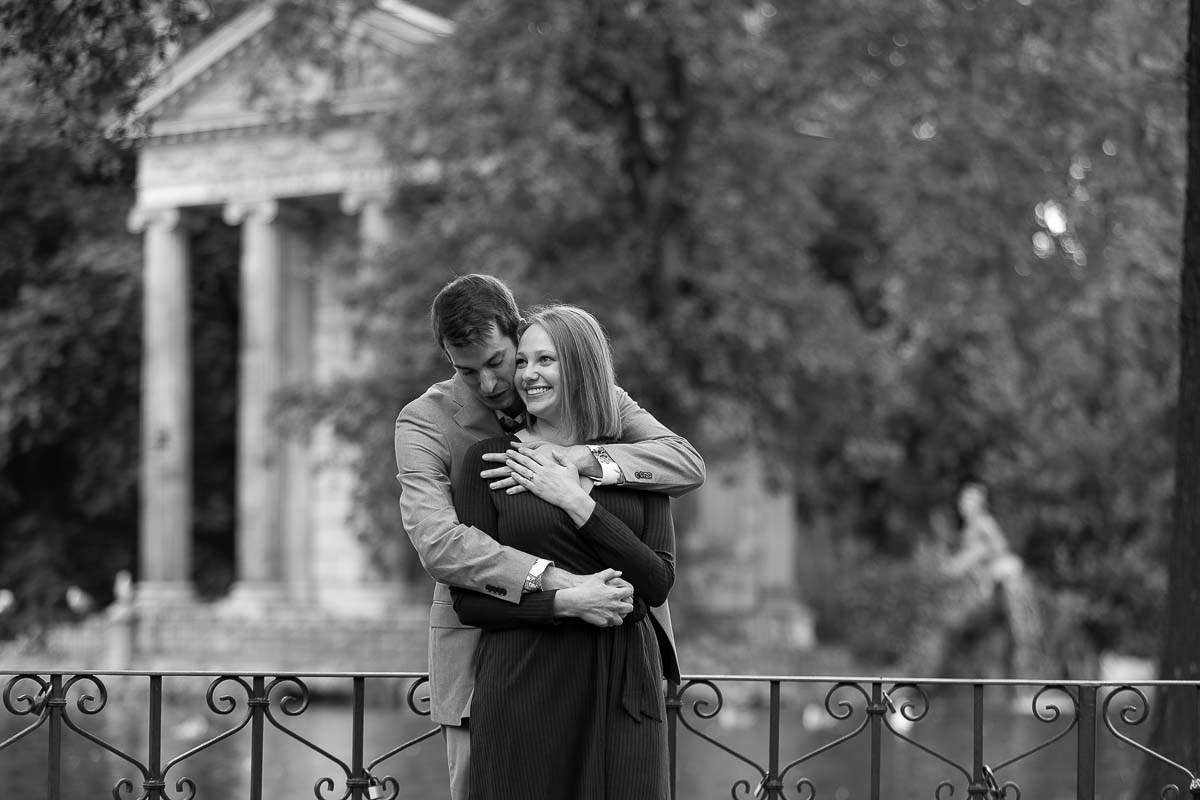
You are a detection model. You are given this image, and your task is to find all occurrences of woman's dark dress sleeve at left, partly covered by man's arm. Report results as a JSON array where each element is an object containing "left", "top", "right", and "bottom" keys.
[{"left": 450, "top": 439, "right": 557, "bottom": 630}]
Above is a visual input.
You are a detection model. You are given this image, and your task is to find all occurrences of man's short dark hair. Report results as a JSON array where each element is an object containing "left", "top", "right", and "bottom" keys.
[{"left": 430, "top": 273, "right": 521, "bottom": 349}]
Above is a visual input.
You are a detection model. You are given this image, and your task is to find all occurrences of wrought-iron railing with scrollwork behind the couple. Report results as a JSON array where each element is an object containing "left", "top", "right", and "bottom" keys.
[{"left": 0, "top": 672, "right": 1200, "bottom": 800}]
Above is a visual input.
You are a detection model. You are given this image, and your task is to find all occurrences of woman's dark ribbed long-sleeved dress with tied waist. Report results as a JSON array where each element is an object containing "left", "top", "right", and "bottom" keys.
[{"left": 455, "top": 438, "right": 674, "bottom": 800}]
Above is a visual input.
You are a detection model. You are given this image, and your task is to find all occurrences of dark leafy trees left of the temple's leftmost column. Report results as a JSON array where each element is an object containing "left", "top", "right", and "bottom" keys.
[{"left": 0, "top": 0, "right": 250, "bottom": 623}]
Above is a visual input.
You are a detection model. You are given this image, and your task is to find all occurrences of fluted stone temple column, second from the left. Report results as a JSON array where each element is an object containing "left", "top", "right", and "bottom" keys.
[{"left": 223, "top": 200, "right": 286, "bottom": 607}]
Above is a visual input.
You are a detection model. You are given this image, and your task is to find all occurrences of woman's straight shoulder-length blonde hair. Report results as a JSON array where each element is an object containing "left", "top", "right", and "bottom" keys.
[{"left": 521, "top": 303, "right": 620, "bottom": 443}]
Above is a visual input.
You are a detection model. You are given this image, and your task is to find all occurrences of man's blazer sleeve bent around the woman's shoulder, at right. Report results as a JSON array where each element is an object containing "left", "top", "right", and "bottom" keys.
[{"left": 604, "top": 387, "right": 704, "bottom": 497}]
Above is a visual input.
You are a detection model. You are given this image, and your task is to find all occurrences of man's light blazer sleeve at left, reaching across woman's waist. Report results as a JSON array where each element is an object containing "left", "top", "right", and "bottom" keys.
[{"left": 396, "top": 397, "right": 535, "bottom": 603}]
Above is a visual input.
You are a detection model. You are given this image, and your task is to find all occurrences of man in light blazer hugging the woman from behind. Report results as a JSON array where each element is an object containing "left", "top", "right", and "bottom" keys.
[{"left": 396, "top": 275, "right": 704, "bottom": 800}]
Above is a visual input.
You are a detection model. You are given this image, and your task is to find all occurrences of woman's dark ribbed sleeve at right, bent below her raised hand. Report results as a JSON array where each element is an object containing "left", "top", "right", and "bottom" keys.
[{"left": 578, "top": 492, "right": 676, "bottom": 606}]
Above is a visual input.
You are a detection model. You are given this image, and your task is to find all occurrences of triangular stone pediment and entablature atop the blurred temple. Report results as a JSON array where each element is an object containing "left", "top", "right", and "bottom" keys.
[{"left": 131, "top": 0, "right": 452, "bottom": 209}]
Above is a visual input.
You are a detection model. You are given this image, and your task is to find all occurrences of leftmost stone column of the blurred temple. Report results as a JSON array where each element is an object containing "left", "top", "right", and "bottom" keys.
[{"left": 128, "top": 209, "right": 192, "bottom": 606}]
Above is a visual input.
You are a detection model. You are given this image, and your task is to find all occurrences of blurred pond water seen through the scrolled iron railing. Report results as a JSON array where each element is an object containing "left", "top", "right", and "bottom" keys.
[{"left": 0, "top": 688, "right": 1138, "bottom": 800}]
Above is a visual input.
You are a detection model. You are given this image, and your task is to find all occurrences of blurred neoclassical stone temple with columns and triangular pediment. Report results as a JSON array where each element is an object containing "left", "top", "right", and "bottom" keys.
[{"left": 128, "top": 1, "right": 451, "bottom": 633}]
